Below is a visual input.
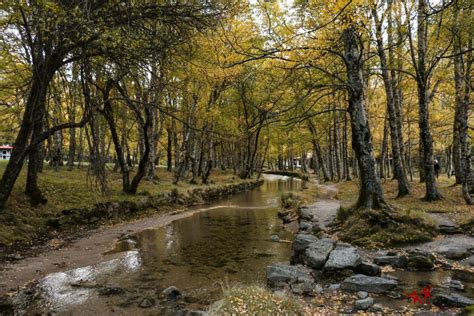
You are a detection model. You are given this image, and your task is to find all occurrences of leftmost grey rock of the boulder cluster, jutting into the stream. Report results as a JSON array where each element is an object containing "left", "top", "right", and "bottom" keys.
[{"left": 267, "top": 262, "right": 314, "bottom": 288}]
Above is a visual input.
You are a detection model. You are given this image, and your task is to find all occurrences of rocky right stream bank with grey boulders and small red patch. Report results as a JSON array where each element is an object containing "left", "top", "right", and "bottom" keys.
[{"left": 267, "top": 185, "right": 474, "bottom": 314}]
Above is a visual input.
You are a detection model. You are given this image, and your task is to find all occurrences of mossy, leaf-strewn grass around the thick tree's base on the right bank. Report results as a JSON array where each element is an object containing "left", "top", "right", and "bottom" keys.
[{"left": 336, "top": 177, "right": 474, "bottom": 247}]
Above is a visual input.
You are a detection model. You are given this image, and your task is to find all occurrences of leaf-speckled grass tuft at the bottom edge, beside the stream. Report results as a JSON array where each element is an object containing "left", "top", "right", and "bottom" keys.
[{"left": 208, "top": 286, "right": 304, "bottom": 315}]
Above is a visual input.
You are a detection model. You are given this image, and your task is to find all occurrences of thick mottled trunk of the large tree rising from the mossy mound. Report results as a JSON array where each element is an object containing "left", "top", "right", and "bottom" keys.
[{"left": 342, "top": 27, "right": 386, "bottom": 209}]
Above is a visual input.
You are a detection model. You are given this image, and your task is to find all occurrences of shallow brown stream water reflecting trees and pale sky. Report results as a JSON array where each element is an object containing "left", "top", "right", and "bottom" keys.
[{"left": 16, "top": 175, "right": 302, "bottom": 314}]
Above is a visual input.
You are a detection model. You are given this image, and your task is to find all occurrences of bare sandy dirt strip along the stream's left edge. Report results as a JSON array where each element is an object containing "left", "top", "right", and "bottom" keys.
[{"left": 0, "top": 205, "right": 237, "bottom": 296}]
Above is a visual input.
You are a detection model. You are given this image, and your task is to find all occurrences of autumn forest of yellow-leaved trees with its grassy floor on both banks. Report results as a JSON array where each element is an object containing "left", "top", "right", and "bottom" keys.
[{"left": 0, "top": 0, "right": 474, "bottom": 314}]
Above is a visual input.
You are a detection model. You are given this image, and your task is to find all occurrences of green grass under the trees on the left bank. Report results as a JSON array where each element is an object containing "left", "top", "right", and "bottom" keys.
[{"left": 0, "top": 161, "right": 240, "bottom": 246}]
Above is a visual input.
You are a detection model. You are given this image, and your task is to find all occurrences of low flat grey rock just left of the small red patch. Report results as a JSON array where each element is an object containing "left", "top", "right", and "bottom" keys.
[{"left": 341, "top": 274, "right": 398, "bottom": 293}]
